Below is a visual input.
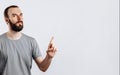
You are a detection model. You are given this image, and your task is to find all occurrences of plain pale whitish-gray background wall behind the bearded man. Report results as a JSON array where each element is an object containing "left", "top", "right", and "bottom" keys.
[{"left": 0, "top": 0, "right": 119, "bottom": 75}]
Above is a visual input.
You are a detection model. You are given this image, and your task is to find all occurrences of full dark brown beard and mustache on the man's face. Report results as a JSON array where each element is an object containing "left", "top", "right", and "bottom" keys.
[{"left": 9, "top": 20, "right": 23, "bottom": 32}]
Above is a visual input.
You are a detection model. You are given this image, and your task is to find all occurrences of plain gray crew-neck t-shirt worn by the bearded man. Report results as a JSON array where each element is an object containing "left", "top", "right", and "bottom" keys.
[{"left": 0, "top": 33, "right": 41, "bottom": 75}]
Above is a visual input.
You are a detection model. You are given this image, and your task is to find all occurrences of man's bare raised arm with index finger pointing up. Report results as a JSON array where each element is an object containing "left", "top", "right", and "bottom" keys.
[{"left": 35, "top": 37, "right": 57, "bottom": 72}]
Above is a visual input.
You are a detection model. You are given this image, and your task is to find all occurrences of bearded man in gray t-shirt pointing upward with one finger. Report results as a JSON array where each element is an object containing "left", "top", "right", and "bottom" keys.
[{"left": 0, "top": 5, "right": 56, "bottom": 75}]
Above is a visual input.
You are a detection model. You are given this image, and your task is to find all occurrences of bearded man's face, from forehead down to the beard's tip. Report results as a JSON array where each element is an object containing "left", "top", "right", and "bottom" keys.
[{"left": 8, "top": 8, "right": 23, "bottom": 32}]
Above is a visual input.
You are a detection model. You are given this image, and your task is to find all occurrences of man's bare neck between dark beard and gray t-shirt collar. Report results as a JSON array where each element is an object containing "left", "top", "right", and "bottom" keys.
[{"left": 7, "top": 31, "right": 22, "bottom": 40}]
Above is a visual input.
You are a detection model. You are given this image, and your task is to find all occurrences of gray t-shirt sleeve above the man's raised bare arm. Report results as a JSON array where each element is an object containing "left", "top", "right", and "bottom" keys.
[{"left": 32, "top": 39, "right": 42, "bottom": 59}]
